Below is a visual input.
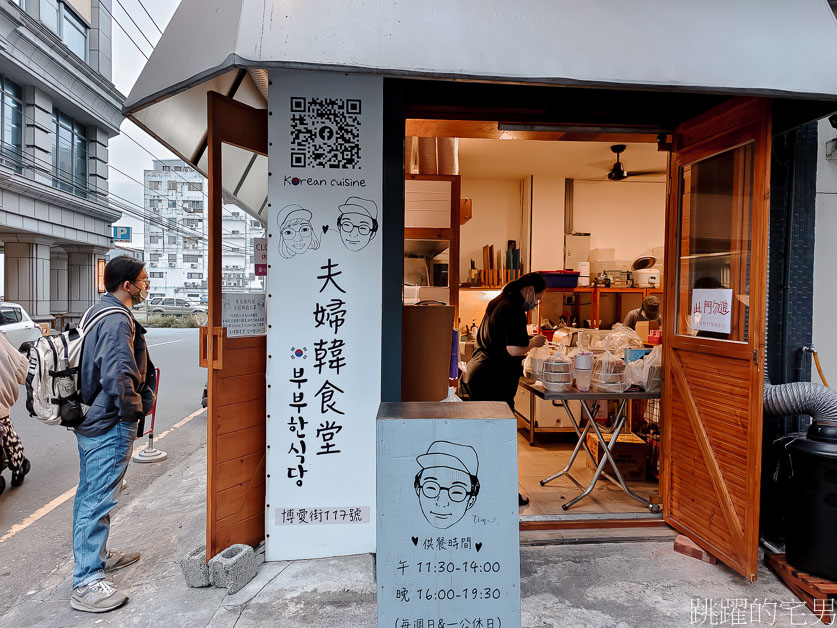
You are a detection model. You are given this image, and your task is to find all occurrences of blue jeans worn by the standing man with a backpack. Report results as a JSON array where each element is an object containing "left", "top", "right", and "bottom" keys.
[{"left": 73, "top": 421, "right": 137, "bottom": 589}]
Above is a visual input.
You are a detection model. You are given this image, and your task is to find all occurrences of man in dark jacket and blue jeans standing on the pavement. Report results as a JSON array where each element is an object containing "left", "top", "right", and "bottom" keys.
[{"left": 70, "top": 256, "right": 155, "bottom": 613}]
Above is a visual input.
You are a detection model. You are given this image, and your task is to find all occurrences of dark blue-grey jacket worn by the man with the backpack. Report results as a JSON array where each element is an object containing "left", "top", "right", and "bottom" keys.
[{"left": 75, "top": 294, "right": 157, "bottom": 436}]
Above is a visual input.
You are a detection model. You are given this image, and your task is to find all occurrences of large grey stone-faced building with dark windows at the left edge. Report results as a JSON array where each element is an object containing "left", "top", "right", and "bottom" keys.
[{"left": 0, "top": 0, "right": 125, "bottom": 324}]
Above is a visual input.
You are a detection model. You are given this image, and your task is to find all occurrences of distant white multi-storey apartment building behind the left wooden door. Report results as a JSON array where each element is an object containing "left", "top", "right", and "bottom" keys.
[{"left": 143, "top": 159, "right": 264, "bottom": 302}]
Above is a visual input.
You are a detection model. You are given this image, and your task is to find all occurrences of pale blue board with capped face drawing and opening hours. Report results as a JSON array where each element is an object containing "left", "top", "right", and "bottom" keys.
[{"left": 376, "top": 414, "right": 520, "bottom": 628}]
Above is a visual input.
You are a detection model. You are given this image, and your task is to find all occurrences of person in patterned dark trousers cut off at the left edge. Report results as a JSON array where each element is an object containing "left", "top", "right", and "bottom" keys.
[{"left": 0, "top": 334, "right": 31, "bottom": 493}]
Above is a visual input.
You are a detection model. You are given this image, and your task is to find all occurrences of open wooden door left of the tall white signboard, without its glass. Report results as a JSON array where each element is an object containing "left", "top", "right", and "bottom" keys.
[{"left": 200, "top": 92, "right": 267, "bottom": 560}]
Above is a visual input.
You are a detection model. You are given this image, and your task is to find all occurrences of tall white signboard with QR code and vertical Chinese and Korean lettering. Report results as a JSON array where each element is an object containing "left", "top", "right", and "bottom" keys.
[{"left": 265, "top": 70, "right": 383, "bottom": 560}]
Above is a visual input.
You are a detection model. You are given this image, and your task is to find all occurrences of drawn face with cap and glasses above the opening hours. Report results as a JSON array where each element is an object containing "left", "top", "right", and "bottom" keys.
[{"left": 414, "top": 440, "right": 480, "bottom": 530}]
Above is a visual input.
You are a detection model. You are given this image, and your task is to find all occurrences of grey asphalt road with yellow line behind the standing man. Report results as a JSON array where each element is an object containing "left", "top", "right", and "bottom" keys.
[{"left": 0, "top": 329, "right": 206, "bottom": 625}]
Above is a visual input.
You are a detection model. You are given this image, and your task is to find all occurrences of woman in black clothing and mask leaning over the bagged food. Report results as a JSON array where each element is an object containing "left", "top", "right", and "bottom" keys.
[{"left": 460, "top": 273, "right": 546, "bottom": 506}]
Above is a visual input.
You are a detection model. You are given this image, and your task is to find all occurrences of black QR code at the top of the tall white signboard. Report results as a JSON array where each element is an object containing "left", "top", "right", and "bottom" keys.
[{"left": 291, "top": 96, "right": 361, "bottom": 170}]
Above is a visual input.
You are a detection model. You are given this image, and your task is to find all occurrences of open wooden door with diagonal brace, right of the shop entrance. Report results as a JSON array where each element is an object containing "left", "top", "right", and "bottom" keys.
[{"left": 661, "top": 98, "right": 771, "bottom": 580}]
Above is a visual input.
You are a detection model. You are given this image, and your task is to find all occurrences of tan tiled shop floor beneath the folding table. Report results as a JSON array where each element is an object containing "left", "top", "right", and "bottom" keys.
[{"left": 517, "top": 431, "right": 659, "bottom": 515}]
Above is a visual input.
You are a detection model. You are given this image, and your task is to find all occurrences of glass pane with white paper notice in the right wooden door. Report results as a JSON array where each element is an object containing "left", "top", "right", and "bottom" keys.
[{"left": 675, "top": 142, "right": 754, "bottom": 342}]
